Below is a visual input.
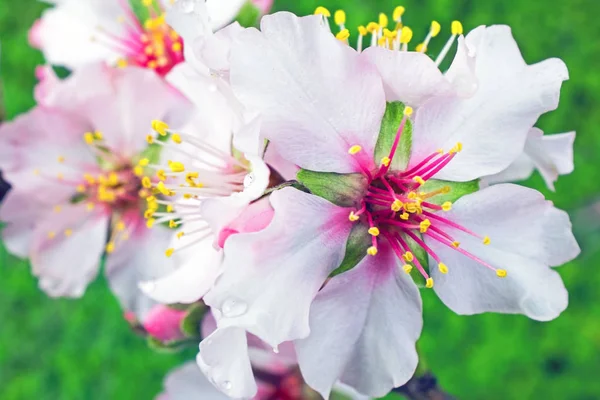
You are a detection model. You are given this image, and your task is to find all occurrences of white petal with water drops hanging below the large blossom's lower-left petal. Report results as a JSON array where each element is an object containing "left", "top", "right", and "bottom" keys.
[{"left": 196, "top": 327, "right": 257, "bottom": 399}]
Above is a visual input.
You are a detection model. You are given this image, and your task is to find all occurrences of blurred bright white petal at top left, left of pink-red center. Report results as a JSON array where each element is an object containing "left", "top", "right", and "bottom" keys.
[{"left": 33, "top": 0, "right": 127, "bottom": 68}]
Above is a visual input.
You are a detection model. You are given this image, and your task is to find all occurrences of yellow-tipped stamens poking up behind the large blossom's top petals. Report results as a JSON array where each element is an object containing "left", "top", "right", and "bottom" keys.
[{"left": 315, "top": 6, "right": 463, "bottom": 65}]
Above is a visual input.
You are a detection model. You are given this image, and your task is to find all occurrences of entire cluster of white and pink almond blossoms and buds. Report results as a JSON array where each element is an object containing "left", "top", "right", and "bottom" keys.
[{"left": 0, "top": 0, "right": 579, "bottom": 400}]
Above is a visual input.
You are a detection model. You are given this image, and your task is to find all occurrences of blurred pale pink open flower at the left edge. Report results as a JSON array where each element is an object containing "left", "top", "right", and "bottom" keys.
[{"left": 0, "top": 64, "right": 190, "bottom": 317}]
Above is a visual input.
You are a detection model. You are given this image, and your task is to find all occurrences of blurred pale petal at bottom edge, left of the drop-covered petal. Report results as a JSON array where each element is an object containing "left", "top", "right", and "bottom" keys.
[{"left": 157, "top": 362, "right": 229, "bottom": 400}]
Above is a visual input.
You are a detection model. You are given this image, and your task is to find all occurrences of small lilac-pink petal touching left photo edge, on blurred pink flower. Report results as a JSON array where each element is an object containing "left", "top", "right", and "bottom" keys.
[{"left": 0, "top": 189, "right": 51, "bottom": 258}]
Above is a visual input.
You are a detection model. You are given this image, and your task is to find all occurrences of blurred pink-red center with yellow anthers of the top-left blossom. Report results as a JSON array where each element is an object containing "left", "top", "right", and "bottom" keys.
[{"left": 94, "top": 0, "right": 183, "bottom": 76}]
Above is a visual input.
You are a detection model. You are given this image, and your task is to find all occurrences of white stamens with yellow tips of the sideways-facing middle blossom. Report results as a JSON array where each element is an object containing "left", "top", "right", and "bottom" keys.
[{"left": 140, "top": 121, "right": 253, "bottom": 257}]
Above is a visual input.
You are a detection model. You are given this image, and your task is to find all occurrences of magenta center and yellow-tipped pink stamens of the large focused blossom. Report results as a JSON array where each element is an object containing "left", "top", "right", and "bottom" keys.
[{"left": 348, "top": 107, "right": 506, "bottom": 288}]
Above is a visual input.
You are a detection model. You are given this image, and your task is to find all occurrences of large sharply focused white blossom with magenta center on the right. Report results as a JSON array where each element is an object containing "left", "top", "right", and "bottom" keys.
[{"left": 191, "top": 12, "right": 579, "bottom": 398}]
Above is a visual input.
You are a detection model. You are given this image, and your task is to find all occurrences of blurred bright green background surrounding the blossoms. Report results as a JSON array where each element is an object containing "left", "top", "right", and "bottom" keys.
[{"left": 0, "top": 0, "right": 600, "bottom": 400}]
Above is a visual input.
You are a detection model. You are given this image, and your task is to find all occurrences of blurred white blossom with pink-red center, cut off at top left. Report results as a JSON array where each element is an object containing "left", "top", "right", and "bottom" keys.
[{"left": 30, "top": 0, "right": 270, "bottom": 76}]
